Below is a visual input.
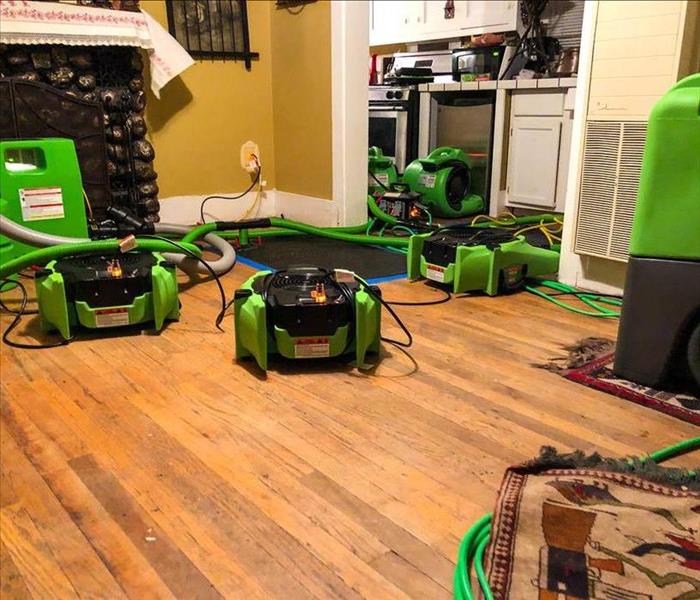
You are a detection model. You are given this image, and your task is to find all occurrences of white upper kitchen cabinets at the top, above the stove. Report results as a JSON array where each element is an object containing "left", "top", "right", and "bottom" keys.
[{"left": 370, "top": 0, "right": 518, "bottom": 46}]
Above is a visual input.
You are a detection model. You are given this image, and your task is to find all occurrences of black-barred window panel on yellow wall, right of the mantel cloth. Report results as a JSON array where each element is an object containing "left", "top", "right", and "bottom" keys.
[{"left": 166, "top": 0, "right": 259, "bottom": 69}]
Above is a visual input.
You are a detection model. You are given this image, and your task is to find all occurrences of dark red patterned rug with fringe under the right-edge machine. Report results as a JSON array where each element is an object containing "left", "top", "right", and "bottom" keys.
[{"left": 540, "top": 338, "right": 700, "bottom": 426}]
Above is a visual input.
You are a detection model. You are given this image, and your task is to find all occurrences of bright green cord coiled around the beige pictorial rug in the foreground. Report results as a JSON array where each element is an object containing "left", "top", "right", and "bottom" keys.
[{"left": 453, "top": 437, "right": 700, "bottom": 600}]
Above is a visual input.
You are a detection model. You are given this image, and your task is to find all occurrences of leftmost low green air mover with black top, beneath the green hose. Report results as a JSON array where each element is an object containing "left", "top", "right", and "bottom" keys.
[{"left": 36, "top": 252, "right": 180, "bottom": 339}]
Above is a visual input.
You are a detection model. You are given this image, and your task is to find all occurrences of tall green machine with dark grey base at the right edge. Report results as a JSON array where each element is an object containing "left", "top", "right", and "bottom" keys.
[{"left": 614, "top": 73, "right": 700, "bottom": 387}]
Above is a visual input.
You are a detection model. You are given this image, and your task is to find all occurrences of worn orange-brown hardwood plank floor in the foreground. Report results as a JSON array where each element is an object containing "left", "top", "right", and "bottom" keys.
[{"left": 0, "top": 265, "right": 697, "bottom": 600}]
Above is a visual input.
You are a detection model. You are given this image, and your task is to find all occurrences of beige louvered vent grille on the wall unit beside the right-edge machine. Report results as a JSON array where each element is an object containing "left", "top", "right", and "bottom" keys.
[{"left": 574, "top": 121, "right": 647, "bottom": 261}]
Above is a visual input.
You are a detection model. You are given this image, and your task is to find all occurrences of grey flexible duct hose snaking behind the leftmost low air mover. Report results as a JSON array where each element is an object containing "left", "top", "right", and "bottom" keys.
[{"left": 0, "top": 215, "right": 236, "bottom": 275}]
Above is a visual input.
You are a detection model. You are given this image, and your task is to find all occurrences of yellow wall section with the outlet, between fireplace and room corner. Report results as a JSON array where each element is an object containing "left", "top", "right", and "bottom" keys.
[{"left": 146, "top": 0, "right": 275, "bottom": 198}]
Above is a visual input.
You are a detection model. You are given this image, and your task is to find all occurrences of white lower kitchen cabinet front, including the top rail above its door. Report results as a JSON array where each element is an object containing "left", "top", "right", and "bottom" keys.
[{"left": 506, "top": 89, "right": 572, "bottom": 211}]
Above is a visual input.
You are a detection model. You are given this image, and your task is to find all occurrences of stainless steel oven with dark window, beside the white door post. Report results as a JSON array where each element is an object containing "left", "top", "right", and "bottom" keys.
[{"left": 369, "top": 85, "right": 418, "bottom": 173}]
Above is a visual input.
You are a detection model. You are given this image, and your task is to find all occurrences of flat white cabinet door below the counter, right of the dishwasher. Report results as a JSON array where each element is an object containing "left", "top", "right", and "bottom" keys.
[{"left": 507, "top": 117, "right": 561, "bottom": 208}]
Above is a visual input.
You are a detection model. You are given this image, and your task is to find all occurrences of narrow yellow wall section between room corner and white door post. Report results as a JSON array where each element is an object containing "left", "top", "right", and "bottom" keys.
[{"left": 270, "top": 1, "right": 333, "bottom": 198}]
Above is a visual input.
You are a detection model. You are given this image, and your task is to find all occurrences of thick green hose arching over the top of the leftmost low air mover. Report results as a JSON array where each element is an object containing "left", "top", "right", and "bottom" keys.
[{"left": 0, "top": 238, "right": 202, "bottom": 279}]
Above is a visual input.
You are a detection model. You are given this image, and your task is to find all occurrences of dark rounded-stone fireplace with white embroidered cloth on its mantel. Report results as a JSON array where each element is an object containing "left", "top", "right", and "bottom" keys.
[{"left": 0, "top": 0, "right": 192, "bottom": 222}]
